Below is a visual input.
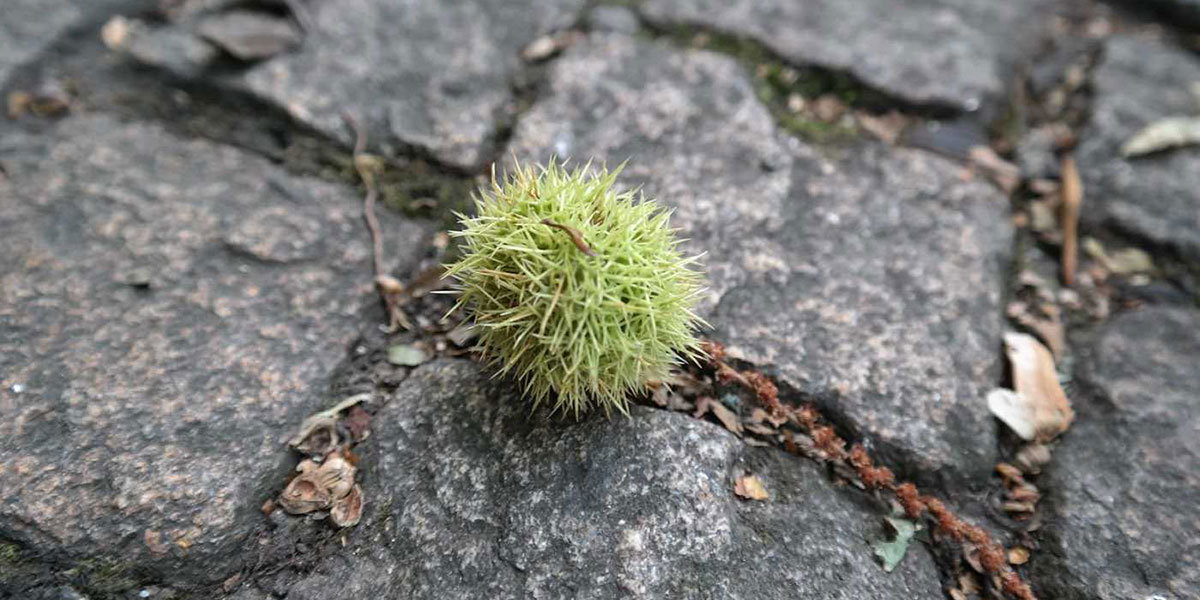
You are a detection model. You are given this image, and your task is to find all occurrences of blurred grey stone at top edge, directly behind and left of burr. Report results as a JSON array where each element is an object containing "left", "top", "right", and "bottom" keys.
[{"left": 117, "top": 0, "right": 583, "bottom": 169}]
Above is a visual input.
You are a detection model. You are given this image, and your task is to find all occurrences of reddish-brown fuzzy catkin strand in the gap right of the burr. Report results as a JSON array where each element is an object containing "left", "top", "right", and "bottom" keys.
[{"left": 667, "top": 338, "right": 1049, "bottom": 600}]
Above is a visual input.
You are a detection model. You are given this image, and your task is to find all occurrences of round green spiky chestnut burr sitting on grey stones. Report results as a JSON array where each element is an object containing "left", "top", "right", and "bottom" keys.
[{"left": 446, "top": 162, "right": 703, "bottom": 418}]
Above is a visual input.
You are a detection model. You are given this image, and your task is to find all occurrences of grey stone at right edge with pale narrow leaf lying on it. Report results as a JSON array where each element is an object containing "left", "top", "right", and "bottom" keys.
[{"left": 1078, "top": 36, "right": 1200, "bottom": 265}]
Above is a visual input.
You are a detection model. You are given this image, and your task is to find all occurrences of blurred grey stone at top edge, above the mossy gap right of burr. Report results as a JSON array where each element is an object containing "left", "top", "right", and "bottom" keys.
[{"left": 641, "top": 0, "right": 1049, "bottom": 110}]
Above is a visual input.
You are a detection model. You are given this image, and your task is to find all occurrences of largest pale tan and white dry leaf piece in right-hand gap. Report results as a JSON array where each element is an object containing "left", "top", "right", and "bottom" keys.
[{"left": 1004, "top": 332, "right": 1075, "bottom": 442}]
